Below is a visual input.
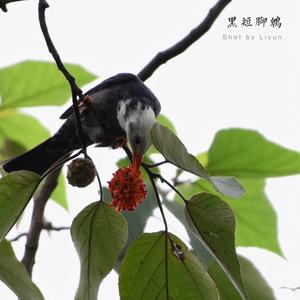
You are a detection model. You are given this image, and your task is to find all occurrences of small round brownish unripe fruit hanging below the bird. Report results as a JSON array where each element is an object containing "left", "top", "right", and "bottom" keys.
[{"left": 67, "top": 158, "right": 96, "bottom": 187}]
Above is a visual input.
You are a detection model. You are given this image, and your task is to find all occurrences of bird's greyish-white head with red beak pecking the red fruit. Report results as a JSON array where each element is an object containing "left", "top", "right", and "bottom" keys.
[{"left": 125, "top": 106, "right": 155, "bottom": 165}]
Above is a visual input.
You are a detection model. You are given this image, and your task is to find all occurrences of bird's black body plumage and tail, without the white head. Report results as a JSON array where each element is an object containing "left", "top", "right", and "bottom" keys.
[{"left": 3, "top": 73, "right": 160, "bottom": 175}]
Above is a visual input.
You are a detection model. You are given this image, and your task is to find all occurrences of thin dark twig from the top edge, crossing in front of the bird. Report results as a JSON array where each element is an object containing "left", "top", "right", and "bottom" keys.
[{"left": 39, "top": 0, "right": 86, "bottom": 156}]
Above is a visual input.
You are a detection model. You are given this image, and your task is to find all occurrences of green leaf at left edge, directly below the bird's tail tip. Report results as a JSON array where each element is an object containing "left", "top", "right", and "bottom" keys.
[{"left": 0, "top": 171, "right": 41, "bottom": 241}]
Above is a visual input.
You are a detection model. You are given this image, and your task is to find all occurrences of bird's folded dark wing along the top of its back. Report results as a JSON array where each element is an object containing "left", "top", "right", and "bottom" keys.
[{"left": 60, "top": 73, "right": 136, "bottom": 119}]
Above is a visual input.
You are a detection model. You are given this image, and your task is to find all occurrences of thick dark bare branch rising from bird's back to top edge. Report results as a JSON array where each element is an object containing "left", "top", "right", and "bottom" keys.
[{"left": 138, "top": 0, "right": 231, "bottom": 81}]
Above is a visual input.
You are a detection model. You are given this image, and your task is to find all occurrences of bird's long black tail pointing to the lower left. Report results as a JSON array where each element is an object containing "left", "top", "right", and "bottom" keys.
[{"left": 2, "top": 138, "right": 70, "bottom": 175}]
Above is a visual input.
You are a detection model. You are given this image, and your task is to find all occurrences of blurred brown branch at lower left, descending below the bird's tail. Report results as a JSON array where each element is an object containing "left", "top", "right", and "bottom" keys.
[{"left": 22, "top": 168, "right": 61, "bottom": 276}]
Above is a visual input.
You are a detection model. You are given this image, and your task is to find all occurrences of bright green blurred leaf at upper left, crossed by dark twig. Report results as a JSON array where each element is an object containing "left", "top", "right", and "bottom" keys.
[{"left": 0, "top": 61, "right": 96, "bottom": 107}]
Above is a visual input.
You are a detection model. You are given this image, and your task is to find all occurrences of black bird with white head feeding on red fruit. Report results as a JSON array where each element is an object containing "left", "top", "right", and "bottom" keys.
[{"left": 2, "top": 73, "right": 161, "bottom": 176}]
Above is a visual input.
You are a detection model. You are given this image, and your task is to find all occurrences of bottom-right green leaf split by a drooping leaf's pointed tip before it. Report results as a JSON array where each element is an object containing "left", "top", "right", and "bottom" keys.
[{"left": 208, "top": 256, "right": 275, "bottom": 300}]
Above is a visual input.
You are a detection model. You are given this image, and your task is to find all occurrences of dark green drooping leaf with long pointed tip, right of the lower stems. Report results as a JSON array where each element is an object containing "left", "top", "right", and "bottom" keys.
[{"left": 185, "top": 193, "right": 247, "bottom": 299}]
